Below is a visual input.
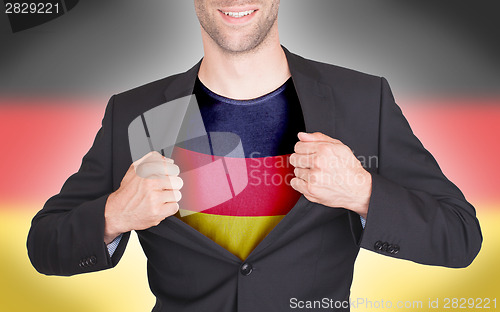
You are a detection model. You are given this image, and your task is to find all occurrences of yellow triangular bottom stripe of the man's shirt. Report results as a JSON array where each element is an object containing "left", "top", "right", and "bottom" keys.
[{"left": 176, "top": 211, "right": 284, "bottom": 260}]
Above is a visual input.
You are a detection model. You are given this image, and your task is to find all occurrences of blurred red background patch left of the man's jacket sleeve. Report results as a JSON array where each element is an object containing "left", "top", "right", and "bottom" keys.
[{"left": 0, "top": 99, "right": 107, "bottom": 202}]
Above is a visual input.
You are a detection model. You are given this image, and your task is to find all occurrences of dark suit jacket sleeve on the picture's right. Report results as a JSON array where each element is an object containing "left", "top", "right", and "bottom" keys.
[{"left": 358, "top": 78, "right": 482, "bottom": 267}]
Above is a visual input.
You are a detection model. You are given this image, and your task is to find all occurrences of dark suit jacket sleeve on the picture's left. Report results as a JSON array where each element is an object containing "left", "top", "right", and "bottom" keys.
[{"left": 27, "top": 97, "right": 130, "bottom": 275}]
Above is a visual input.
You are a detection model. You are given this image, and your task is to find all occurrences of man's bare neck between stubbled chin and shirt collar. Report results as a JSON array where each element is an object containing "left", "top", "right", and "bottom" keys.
[{"left": 198, "top": 30, "right": 291, "bottom": 100}]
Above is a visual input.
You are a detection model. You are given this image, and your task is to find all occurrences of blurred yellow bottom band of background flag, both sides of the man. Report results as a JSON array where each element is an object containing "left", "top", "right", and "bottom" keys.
[{"left": 0, "top": 205, "right": 500, "bottom": 312}]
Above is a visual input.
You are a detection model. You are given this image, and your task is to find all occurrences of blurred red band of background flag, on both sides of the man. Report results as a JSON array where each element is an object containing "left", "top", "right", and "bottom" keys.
[{"left": 0, "top": 98, "right": 500, "bottom": 209}]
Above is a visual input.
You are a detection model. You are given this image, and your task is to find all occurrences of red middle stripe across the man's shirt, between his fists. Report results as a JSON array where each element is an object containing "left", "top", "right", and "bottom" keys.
[{"left": 172, "top": 147, "right": 300, "bottom": 217}]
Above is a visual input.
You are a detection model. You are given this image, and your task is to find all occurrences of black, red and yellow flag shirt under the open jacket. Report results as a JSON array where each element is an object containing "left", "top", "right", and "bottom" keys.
[{"left": 172, "top": 78, "right": 305, "bottom": 260}]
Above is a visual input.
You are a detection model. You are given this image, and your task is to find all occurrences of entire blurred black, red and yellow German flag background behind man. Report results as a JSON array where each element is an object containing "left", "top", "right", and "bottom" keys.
[{"left": 0, "top": 0, "right": 500, "bottom": 312}]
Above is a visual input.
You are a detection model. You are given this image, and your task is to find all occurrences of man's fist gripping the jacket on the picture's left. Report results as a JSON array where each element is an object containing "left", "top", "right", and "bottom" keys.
[{"left": 104, "top": 152, "right": 183, "bottom": 244}]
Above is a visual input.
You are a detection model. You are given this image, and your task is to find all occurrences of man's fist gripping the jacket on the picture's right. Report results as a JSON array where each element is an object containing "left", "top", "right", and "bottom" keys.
[{"left": 290, "top": 132, "right": 372, "bottom": 218}]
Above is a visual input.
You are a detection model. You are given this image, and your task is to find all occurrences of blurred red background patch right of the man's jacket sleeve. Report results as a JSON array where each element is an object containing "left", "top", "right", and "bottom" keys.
[{"left": 403, "top": 99, "right": 500, "bottom": 204}]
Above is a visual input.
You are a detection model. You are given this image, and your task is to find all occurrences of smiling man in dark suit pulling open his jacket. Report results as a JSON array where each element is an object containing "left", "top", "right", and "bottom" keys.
[{"left": 27, "top": 0, "right": 482, "bottom": 311}]
